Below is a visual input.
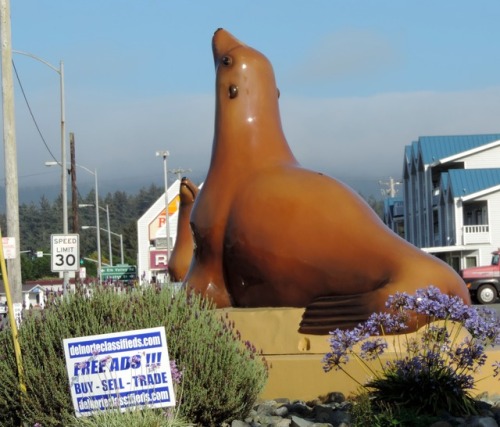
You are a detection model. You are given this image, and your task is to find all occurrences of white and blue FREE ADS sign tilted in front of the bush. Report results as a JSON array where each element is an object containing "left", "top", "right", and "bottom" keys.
[{"left": 63, "top": 327, "right": 175, "bottom": 417}]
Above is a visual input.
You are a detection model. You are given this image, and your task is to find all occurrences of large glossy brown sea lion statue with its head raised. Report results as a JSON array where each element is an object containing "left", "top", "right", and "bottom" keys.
[{"left": 184, "top": 29, "right": 470, "bottom": 334}]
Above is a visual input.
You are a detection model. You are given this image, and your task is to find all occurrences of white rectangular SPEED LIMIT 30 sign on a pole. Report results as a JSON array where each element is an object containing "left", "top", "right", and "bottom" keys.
[{"left": 50, "top": 234, "right": 80, "bottom": 271}]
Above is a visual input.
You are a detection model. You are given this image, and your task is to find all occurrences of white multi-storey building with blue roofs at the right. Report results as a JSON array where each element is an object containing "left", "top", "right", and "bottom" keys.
[{"left": 400, "top": 134, "right": 500, "bottom": 271}]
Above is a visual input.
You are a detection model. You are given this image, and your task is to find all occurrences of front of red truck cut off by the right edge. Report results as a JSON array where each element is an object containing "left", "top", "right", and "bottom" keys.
[{"left": 460, "top": 250, "right": 500, "bottom": 304}]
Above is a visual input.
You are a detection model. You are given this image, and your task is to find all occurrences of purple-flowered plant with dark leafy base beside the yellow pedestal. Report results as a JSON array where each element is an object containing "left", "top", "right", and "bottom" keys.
[{"left": 323, "top": 286, "right": 500, "bottom": 415}]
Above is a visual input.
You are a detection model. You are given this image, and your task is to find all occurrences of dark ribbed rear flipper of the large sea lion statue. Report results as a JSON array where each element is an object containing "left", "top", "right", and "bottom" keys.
[{"left": 299, "top": 292, "right": 375, "bottom": 335}]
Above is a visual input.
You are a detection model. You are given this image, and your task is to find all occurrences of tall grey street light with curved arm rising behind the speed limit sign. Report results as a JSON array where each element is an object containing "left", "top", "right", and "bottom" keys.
[{"left": 16, "top": 50, "right": 69, "bottom": 294}]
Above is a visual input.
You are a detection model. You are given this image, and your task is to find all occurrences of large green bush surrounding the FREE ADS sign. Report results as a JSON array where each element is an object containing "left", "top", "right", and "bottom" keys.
[{"left": 0, "top": 286, "right": 267, "bottom": 427}]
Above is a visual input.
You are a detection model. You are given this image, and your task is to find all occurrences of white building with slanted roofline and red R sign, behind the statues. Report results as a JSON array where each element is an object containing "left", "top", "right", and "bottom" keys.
[{"left": 137, "top": 180, "right": 181, "bottom": 282}]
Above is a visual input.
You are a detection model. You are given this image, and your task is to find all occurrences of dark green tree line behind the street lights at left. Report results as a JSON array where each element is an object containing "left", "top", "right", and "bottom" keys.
[{"left": 0, "top": 184, "right": 164, "bottom": 282}]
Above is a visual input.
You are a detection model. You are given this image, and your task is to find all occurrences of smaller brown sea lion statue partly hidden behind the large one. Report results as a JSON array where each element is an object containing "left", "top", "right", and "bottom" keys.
[{"left": 168, "top": 177, "right": 199, "bottom": 282}]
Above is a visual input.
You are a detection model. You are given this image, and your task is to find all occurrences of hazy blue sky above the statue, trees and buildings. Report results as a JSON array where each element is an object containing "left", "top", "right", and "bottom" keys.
[{"left": 1, "top": 0, "right": 500, "bottom": 197}]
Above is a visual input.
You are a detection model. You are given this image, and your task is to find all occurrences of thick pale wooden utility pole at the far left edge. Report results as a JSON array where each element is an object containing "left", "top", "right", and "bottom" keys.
[{"left": 0, "top": 0, "right": 23, "bottom": 311}]
